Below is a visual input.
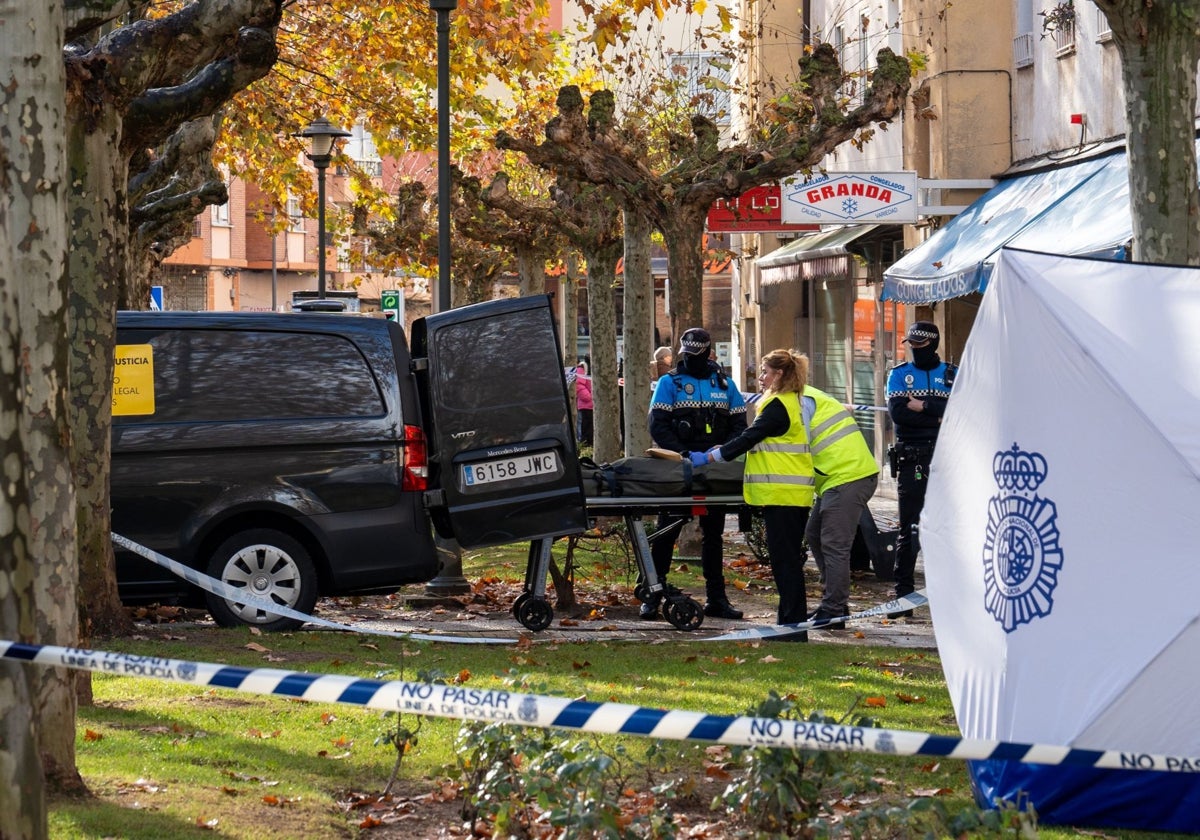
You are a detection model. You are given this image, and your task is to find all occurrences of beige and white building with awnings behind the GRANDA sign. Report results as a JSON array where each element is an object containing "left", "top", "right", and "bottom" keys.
[{"left": 732, "top": 0, "right": 1200, "bottom": 452}]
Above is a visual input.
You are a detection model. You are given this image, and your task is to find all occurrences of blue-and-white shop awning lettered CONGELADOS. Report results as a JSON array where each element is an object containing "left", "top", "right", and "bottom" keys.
[{"left": 883, "top": 155, "right": 1113, "bottom": 304}]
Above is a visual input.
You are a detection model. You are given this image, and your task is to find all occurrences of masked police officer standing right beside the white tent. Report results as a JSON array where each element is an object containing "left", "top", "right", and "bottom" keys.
[{"left": 887, "top": 320, "right": 958, "bottom": 618}]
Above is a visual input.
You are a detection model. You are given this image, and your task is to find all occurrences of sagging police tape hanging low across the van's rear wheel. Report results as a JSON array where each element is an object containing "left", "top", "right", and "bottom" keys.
[{"left": 112, "top": 533, "right": 929, "bottom": 644}]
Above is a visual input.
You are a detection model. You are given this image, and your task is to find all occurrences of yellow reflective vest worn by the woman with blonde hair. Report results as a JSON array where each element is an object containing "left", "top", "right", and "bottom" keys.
[{"left": 742, "top": 394, "right": 816, "bottom": 508}]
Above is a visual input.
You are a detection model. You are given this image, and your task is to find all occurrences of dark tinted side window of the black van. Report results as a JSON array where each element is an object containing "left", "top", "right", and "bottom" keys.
[{"left": 114, "top": 330, "right": 385, "bottom": 424}]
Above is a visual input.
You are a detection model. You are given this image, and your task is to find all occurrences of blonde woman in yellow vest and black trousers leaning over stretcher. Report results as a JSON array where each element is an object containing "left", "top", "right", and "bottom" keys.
[{"left": 691, "top": 349, "right": 816, "bottom": 642}]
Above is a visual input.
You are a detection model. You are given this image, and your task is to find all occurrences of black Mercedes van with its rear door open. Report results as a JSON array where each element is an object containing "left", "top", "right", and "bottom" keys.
[{"left": 112, "top": 295, "right": 586, "bottom": 630}]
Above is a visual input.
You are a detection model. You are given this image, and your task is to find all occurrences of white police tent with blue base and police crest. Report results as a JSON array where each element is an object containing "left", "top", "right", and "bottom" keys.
[{"left": 920, "top": 248, "right": 1200, "bottom": 833}]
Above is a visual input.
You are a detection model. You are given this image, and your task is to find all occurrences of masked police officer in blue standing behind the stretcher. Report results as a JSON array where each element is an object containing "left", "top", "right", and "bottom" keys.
[{"left": 641, "top": 328, "right": 746, "bottom": 619}]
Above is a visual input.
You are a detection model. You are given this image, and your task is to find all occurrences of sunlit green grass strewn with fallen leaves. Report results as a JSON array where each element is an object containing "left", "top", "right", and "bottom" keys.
[{"left": 50, "top": 550, "right": 1168, "bottom": 839}]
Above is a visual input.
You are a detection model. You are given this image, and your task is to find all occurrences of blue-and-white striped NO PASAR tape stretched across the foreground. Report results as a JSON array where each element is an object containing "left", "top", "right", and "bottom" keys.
[{"left": 0, "top": 641, "right": 1200, "bottom": 773}]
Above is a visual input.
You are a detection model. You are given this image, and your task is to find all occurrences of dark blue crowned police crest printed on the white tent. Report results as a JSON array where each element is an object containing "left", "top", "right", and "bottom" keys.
[{"left": 983, "top": 443, "right": 1062, "bottom": 632}]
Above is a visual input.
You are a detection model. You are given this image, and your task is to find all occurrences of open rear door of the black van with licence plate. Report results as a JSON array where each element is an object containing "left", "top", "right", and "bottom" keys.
[{"left": 410, "top": 295, "right": 587, "bottom": 547}]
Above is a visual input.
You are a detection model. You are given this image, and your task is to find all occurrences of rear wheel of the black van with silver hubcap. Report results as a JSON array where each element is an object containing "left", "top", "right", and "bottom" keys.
[{"left": 208, "top": 528, "right": 318, "bottom": 630}]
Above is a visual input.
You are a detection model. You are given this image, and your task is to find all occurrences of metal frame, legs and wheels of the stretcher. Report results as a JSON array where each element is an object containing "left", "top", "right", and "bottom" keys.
[{"left": 512, "top": 496, "right": 745, "bottom": 632}]
